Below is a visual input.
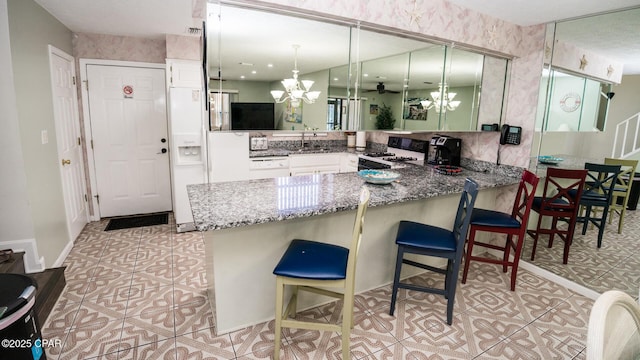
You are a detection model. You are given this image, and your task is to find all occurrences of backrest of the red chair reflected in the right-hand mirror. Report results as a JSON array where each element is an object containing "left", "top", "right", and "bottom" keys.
[{"left": 540, "top": 167, "right": 587, "bottom": 217}]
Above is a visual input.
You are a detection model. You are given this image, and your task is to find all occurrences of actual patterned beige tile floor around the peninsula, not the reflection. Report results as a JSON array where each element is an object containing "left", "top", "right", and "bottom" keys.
[{"left": 42, "top": 214, "right": 609, "bottom": 360}]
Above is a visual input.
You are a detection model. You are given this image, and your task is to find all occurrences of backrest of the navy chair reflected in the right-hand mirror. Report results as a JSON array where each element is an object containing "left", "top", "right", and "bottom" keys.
[{"left": 581, "top": 163, "right": 620, "bottom": 206}]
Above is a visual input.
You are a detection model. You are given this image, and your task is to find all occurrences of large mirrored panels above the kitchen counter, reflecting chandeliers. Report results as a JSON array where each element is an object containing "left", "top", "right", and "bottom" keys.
[{"left": 207, "top": 3, "right": 510, "bottom": 131}]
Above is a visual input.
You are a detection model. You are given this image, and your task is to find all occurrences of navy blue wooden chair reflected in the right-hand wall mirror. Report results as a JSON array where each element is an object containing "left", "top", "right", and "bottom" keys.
[{"left": 569, "top": 163, "right": 620, "bottom": 248}]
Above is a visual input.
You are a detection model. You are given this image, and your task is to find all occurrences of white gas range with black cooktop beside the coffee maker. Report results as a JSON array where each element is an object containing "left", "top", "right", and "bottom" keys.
[{"left": 358, "top": 136, "right": 429, "bottom": 170}]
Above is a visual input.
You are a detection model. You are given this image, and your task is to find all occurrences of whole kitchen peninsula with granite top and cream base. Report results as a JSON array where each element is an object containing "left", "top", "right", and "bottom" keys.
[{"left": 188, "top": 165, "right": 519, "bottom": 334}]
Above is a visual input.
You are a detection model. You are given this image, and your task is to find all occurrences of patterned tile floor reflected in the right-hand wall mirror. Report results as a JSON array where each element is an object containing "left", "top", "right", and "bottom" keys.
[{"left": 522, "top": 205, "right": 640, "bottom": 299}]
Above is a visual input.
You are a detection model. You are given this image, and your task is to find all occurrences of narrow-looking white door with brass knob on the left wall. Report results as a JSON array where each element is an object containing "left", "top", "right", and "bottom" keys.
[{"left": 49, "top": 46, "right": 88, "bottom": 241}]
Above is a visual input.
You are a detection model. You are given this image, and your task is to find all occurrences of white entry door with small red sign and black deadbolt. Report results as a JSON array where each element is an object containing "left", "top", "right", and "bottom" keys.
[{"left": 87, "top": 65, "right": 171, "bottom": 217}]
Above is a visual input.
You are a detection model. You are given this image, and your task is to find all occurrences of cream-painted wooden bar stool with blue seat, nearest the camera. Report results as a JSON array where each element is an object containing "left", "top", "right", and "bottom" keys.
[{"left": 273, "top": 187, "right": 369, "bottom": 359}]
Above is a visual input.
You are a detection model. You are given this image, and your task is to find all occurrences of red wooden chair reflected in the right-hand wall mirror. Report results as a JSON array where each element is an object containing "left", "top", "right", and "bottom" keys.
[{"left": 527, "top": 167, "right": 587, "bottom": 264}]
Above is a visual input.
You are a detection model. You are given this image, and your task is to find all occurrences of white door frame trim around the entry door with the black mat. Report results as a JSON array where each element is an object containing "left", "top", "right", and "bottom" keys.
[{"left": 79, "top": 59, "right": 167, "bottom": 221}]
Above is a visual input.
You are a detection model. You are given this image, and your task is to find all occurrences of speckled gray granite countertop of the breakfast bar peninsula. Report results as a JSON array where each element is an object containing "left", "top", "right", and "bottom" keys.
[{"left": 187, "top": 166, "right": 520, "bottom": 231}]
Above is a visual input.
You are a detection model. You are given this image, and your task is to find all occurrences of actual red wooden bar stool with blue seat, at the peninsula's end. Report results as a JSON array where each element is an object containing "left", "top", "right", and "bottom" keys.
[{"left": 462, "top": 170, "right": 540, "bottom": 291}]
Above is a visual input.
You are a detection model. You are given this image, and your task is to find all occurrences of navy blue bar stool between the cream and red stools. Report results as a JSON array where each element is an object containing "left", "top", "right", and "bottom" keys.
[{"left": 389, "top": 179, "right": 478, "bottom": 325}]
